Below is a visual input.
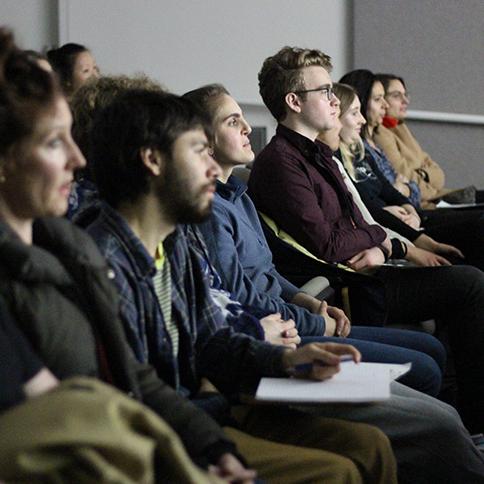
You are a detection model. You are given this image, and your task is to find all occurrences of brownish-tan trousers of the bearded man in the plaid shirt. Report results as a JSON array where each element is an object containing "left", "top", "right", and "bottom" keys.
[{"left": 233, "top": 405, "right": 397, "bottom": 484}]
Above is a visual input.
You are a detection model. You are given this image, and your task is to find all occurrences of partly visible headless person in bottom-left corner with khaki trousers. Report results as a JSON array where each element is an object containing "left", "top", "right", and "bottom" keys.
[{"left": 0, "top": 297, "right": 217, "bottom": 484}]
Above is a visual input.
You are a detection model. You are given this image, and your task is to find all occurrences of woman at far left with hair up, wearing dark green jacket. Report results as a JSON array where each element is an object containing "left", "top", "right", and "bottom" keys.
[{"left": 0, "top": 29, "right": 262, "bottom": 480}]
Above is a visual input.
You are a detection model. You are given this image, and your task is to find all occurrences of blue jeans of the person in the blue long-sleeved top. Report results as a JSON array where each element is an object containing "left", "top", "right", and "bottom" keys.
[{"left": 301, "top": 326, "right": 446, "bottom": 396}]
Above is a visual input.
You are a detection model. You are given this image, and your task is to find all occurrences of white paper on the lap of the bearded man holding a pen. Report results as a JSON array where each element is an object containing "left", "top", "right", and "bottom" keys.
[{"left": 255, "top": 362, "right": 411, "bottom": 404}]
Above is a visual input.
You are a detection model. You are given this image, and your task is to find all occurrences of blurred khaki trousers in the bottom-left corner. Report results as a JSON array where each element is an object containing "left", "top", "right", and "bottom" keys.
[{"left": 0, "top": 378, "right": 222, "bottom": 484}]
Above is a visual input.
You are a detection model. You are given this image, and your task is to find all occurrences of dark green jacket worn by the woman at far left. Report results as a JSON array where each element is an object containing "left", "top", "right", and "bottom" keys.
[{"left": 0, "top": 218, "right": 235, "bottom": 465}]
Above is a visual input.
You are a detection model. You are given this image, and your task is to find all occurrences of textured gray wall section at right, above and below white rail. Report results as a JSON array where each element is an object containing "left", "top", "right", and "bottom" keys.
[{"left": 353, "top": 0, "right": 484, "bottom": 189}]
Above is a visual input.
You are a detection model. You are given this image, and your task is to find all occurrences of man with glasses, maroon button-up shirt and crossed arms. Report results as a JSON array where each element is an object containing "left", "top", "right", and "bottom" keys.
[{"left": 249, "top": 47, "right": 484, "bottom": 432}]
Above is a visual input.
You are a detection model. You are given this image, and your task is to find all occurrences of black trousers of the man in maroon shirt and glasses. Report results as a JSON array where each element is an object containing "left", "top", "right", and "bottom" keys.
[{"left": 378, "top": 266, "right": 484, "bottom": 433}]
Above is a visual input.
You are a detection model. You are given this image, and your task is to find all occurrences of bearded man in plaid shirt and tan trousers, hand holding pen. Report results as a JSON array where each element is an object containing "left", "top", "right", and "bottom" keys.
[{"left": 88, "top": 90, "right": 395, "bottom": 483}]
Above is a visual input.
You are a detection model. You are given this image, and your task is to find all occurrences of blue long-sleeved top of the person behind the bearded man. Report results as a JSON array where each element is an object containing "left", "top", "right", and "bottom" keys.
[{"left": 200, "top": 176, "right": 325, "bottom": 336}]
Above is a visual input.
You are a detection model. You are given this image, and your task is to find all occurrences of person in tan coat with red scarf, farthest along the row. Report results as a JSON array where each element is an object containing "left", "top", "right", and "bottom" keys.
[{"left": 375, "top": 74, "right": 484, "bottom": 207}]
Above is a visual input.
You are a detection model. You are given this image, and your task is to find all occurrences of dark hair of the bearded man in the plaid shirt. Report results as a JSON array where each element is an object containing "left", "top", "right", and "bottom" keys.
[{"left": 90, "top": 89, "right": 211, "bottom": 208}]
